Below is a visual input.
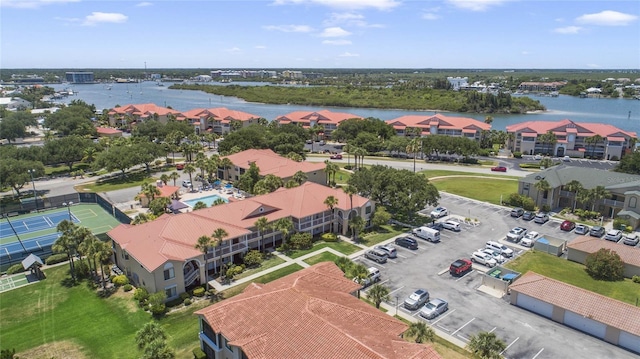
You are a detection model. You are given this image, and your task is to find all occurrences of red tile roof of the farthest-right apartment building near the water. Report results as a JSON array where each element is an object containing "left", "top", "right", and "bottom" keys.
[{"left": 507, "top": 119, "right": 637, "bottom": 138}]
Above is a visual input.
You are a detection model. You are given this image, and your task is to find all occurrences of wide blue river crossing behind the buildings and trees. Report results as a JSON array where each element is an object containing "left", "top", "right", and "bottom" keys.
[{"left": 48, "top": 81, "right": 640, "bottom": 133}]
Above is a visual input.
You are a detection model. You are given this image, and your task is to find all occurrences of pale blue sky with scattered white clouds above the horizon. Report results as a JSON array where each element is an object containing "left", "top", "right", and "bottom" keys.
[{"left": 0, "top": 0, "right": 640, "bottom": 69}]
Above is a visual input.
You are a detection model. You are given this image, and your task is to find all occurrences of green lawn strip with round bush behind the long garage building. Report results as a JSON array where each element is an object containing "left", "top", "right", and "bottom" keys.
[{"left": 505, "top": 251, "right": 640, "bottom": 305}]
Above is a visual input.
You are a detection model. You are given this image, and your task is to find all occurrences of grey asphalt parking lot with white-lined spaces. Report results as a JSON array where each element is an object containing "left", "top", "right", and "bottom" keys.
[{"left": 356, "top": 193, "right": 637, "bottom": 358}]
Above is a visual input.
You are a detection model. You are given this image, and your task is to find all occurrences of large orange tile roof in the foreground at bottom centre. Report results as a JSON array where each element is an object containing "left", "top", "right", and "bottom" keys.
[{"left": 196, "top": 262, "right": 440, "bottom": 359}]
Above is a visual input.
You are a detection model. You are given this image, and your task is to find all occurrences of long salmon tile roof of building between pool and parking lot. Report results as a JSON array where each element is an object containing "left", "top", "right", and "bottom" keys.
[{"left": 107, "top": 182, "right": 369, "bottom": 272}]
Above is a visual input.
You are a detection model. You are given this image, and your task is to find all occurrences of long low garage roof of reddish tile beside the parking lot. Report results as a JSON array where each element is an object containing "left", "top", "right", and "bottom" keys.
[{"left": 509, "top": 272, "right": 640, "bottom": 335}]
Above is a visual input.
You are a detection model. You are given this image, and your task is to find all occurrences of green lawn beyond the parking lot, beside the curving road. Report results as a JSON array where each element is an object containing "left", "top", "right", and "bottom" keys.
[{"left": 431, "top": 176, "right": 518, "bottom": 204}]
